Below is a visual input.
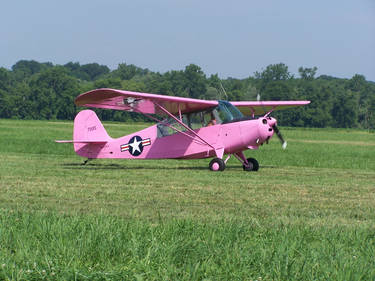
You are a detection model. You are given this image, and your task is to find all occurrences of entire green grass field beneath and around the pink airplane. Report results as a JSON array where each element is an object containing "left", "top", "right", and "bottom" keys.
[{"left": 0, "top": 120, "right": 375, "bottom": 280}]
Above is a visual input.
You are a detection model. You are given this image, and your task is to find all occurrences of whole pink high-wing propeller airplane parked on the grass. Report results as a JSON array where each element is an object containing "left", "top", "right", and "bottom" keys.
[{"left": 57, "top": 89, "right": 310, "bottom": 171}]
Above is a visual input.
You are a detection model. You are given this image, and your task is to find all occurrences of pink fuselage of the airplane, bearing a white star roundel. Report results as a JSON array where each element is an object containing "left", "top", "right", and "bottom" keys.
[{"left": 75, "top": 117, "right": 276, "bottom": 159}]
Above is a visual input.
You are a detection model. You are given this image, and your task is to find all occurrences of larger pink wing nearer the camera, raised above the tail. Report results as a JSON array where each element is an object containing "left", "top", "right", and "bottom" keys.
[{"left": 75, "top": 88, "right": 218, "bottom": 115}]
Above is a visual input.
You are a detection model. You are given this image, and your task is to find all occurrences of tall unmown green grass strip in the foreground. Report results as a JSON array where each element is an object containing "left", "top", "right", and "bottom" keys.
[{"left": 0, "top": 211, "right": 375, "bottom": 280}]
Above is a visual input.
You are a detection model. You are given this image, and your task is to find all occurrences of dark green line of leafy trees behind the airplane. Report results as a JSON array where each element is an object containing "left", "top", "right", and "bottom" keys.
[{"left": 0, "top": 60, "right": 375, "bottom": 129}]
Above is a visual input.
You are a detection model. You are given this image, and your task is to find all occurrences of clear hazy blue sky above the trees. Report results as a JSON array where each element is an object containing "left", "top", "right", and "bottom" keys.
[{"left": 0, "top": 0, "right": 375, "bottom": 81}]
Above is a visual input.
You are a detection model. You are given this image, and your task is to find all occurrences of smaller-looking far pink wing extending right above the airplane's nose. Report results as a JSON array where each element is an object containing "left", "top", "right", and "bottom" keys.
[{"left": 230, "top": 101, "right": 310, "bottom": 116}]
